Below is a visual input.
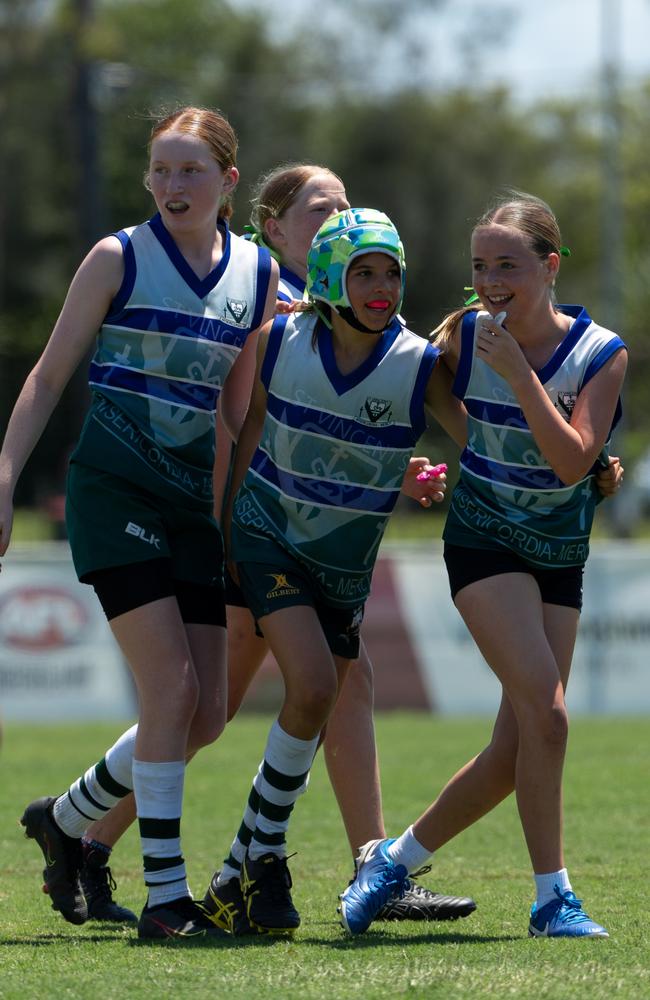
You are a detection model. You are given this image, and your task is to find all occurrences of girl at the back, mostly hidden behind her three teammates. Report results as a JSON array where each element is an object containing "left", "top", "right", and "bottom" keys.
[{"left": 197, "top": 170, "right": 475, "bottom": 934}]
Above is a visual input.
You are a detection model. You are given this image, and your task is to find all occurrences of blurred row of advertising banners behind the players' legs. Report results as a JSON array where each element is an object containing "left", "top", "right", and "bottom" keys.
[{"left": 0, "top": 541, "right": 650, "bottom": 722}]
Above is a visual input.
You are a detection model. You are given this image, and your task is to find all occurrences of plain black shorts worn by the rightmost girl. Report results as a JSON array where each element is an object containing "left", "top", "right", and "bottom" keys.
[{"left": 444, "top": 542, "right": 584, "bottom": 611}]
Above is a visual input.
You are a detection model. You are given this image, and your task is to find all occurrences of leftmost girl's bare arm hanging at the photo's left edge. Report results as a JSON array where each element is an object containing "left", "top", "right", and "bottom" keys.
[{"left": 0, "top": 237, "right": 124, "bottom": 555}]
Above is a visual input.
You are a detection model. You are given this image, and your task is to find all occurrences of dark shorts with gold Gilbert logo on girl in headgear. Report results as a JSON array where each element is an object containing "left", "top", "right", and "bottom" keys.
[{"left": 237, "top": 536, "right": 364, "bottom": 660}]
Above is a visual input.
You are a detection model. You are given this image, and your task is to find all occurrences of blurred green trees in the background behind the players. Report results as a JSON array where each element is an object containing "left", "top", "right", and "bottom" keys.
[{"left": 0, "top": 0, "right": 650, "bottom": 502}]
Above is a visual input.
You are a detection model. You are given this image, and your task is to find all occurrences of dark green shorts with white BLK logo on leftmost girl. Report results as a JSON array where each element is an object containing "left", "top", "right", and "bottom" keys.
[{"left": 65, "top": 462, "right": 223, "bottom": 586}]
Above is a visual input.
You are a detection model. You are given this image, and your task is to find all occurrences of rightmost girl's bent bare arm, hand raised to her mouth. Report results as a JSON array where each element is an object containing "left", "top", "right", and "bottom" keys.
[{"left": 476, "top": 312, "right": 627, "bottom": 486}]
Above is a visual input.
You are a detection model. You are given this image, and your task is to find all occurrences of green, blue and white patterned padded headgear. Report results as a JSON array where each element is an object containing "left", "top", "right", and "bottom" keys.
[{"left": 306, "top": 208, "right": 406, "bottom": 315}]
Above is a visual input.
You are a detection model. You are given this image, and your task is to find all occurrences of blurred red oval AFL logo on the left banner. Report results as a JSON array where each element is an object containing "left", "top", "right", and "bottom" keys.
[{"left": 0, "top": 585, "right": 89, "bottom": 653}]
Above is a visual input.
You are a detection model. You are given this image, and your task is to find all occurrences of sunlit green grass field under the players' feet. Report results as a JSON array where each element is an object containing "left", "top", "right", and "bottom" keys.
[{"left": 0, "top": 715, "right": 650, "bottom": 1000}]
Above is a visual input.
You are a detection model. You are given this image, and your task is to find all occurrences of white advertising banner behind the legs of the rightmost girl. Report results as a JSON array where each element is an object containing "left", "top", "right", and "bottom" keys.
[{"left": 390, "top": 542, "right": 650, "bottom": 715}]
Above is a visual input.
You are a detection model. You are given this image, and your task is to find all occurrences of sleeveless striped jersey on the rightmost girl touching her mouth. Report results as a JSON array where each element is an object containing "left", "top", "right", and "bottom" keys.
[{"left": 443, "top": 306, "right": 625, "bottom": 568}]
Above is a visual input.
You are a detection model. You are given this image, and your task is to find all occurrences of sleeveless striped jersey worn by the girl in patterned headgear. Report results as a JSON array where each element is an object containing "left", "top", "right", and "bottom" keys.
[{"left": 233, "top": 312, "right": 438, "bottom": 607}]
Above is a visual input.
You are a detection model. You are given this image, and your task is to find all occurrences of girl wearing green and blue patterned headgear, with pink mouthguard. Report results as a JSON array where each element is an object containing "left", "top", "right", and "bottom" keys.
[{"left": 211, "top": 209, "right": 462, "bottom": 933}]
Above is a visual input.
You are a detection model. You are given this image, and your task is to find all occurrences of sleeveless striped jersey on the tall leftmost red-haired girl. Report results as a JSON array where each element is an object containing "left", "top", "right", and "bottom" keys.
[{"left": 72, "top": 215, "right": 270, "bottom": 508}]
